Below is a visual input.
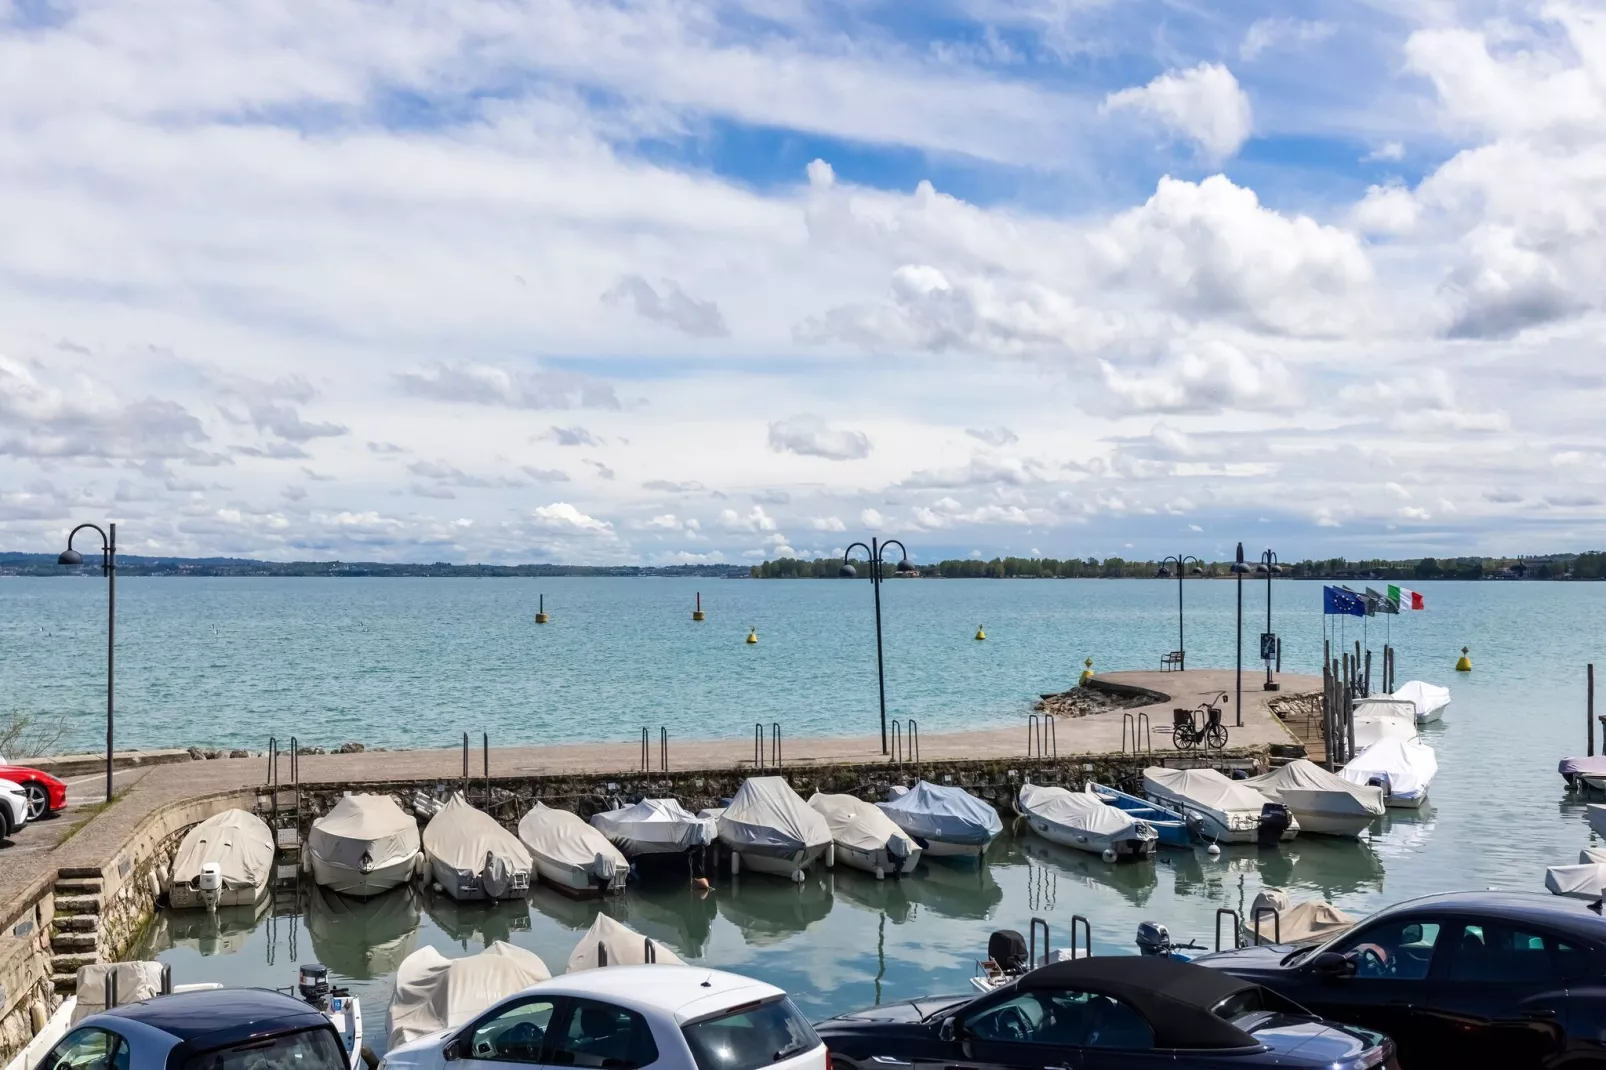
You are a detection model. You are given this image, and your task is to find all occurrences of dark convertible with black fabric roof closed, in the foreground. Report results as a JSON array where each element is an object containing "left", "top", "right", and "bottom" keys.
[{"left": 814, "top": 956, "right": 1394, "bottom": 1070}]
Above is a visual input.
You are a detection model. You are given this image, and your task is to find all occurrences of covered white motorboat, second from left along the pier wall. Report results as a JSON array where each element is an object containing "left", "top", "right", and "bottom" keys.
[{"left": 307, "top": 795, "right": 422, "bottom": 898}]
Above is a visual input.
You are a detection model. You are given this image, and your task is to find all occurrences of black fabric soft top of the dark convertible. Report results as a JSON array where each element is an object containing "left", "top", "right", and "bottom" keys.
[{"left": 1013, "top": 954, "right": 1257, "bottom": 1049}]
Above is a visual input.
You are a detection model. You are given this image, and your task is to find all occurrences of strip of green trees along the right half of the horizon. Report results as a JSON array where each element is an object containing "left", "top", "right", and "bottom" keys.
[{"left": 752, "top": 551, "right": 1606, "bottom": 582}]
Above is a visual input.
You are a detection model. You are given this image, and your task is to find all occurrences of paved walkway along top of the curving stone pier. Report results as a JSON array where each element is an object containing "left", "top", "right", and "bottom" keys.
[{"left": 0, "top": 668, "right": 1322, "bottom": 917}]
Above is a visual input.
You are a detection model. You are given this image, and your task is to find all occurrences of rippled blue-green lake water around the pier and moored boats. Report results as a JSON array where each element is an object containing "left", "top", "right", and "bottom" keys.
[{"left": 46, "top": 580, "right": 1606, "bottom": 1048}]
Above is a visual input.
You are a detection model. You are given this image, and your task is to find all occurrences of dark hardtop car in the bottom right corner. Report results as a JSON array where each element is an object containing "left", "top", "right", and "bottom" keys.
[{"left": 1195, "top": 892, "right": 1606, "bottom": 1070}]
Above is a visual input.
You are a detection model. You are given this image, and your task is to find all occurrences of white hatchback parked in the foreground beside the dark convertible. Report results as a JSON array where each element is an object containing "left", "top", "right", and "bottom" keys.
[{"left": 379, "top": 966, "right": 830, "bottom": 1070}]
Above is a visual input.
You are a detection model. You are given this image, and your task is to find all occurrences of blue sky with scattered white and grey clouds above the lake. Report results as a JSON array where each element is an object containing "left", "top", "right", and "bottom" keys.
[{"left": 0, "top": 0, "right": 1606, "bottom": 564}]
